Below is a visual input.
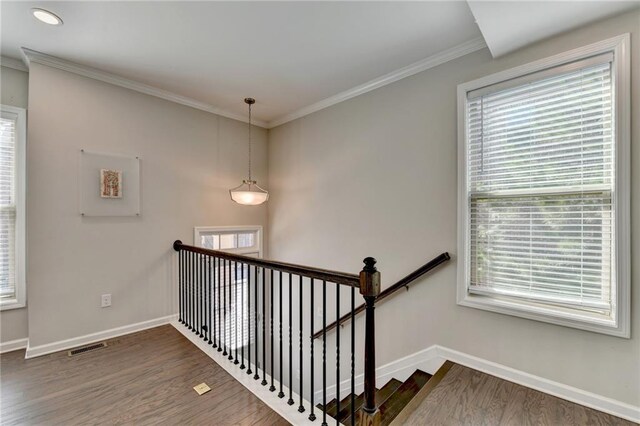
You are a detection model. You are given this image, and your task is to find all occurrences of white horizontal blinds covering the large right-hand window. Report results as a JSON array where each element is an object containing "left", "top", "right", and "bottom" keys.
[{"left": 467, "top": 56, "right": 615, "bottom": 312}]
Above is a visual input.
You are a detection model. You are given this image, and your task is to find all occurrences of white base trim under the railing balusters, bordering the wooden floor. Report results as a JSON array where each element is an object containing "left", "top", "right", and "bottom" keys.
[{"left": 171, "top": 320, "right": 320, "bottom": 426}]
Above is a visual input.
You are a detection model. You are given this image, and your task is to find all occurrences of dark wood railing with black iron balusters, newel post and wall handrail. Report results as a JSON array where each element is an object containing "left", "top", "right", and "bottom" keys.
[{"left": 173, "top": 240, "right": 448, "bottom": 425}]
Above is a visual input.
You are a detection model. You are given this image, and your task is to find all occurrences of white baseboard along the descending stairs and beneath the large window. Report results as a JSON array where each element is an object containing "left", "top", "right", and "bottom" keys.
[{"left": 314, "top": 345, "right": 640, "bottom": 423}]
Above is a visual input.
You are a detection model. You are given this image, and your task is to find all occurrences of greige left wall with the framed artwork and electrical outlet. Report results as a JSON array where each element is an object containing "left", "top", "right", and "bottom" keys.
[{"left": 27, "top": 64, "right": 267, "bottom": 347}]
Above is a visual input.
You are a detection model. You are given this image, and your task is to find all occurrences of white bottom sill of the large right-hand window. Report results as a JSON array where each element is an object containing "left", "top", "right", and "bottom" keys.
[{"left": 458, "top": 293, "right": 631, "bottom": 339}]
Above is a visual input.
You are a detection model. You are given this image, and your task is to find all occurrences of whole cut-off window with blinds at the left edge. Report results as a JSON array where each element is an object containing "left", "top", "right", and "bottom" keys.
[{"left": 0, "top": 105, "right": 24, "bottom": 308}]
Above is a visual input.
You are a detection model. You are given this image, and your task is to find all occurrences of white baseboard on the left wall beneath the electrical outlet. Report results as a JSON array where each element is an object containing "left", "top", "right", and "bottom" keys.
[{"left": 25, "top": 315, "right": 177, "bottom": 359}]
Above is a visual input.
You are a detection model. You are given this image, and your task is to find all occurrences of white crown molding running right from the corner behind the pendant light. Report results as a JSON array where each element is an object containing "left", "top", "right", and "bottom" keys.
[{"left": 267, "top": 37, "right": 487, "bottom": 129}]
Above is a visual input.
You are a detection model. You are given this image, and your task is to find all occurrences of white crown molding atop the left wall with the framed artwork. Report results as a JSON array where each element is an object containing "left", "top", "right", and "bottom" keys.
[{"left": 21, "top": 47, "right": 267, "bottom": 128}]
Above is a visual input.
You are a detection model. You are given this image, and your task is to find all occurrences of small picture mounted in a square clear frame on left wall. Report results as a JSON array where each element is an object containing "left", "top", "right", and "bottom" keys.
[{"left": 78, "top": 149, "right": 141, "bottom": 217}]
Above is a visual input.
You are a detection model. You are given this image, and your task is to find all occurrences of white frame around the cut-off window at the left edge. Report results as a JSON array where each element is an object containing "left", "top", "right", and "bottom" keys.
[{"left": 0, "top": 104, "right": 27, "bottom": 311}]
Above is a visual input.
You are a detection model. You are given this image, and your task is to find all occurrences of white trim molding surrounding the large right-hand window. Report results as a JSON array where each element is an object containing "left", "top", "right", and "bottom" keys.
[{"left": 457, "top": 33, "right": 631, "bottom": 339}]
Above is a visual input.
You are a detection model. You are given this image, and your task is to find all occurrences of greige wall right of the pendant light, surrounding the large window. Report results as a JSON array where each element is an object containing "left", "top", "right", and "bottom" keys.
[{"left": 268, "top": 11, "right": 640, "bottom": 406}]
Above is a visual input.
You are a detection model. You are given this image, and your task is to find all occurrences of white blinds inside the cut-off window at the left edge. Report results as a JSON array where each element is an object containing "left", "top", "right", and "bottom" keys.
[{"left": 0, "top": 114, "right": 16, "bottom": 299}]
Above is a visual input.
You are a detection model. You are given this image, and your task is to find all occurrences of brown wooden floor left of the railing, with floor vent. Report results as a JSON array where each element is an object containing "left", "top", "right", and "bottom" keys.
[{"left": 0, "top": 325, "right": 288, "bottom": 425}]
